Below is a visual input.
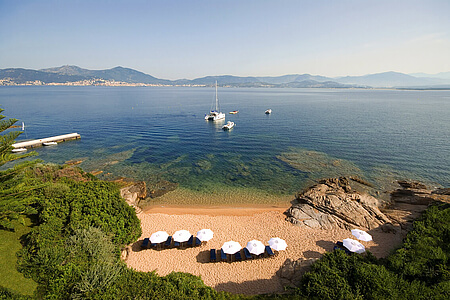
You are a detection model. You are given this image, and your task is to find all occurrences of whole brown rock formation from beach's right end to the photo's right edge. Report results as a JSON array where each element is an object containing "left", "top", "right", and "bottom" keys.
[{"left": 285, "top": 177, "right": 450, "bottom": 233}]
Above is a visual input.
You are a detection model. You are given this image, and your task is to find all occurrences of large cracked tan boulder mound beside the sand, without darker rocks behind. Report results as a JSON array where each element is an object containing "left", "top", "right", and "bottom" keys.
[{"left": 285, "top": 177, "right": 390, "bottom": 229}]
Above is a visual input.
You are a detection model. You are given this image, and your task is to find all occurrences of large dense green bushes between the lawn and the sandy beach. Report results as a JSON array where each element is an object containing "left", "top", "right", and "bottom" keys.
[{"left": 14, "top": 165, "right": 141, "bottom": 299}]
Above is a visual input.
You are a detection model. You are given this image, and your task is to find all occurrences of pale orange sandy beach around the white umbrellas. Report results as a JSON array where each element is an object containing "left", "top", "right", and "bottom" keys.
[{"left": 127, "top": 205, "right": 402, "bottom": 294}]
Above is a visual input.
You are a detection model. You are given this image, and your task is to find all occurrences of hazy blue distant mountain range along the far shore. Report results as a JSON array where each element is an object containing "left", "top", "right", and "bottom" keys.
[{"left": 0, "top": 65, "right": 450, "bottom": 88}]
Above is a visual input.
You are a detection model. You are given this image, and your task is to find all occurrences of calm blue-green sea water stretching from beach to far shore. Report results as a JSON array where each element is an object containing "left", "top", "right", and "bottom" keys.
[{"left": 0, "top": 86, "right": 450, "bottom": 194}]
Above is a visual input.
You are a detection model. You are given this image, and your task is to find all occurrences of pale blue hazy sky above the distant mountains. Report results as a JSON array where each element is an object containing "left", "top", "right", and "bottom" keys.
[{"left": 0, "top": 0, "right": 450, "bottom": 80}]
